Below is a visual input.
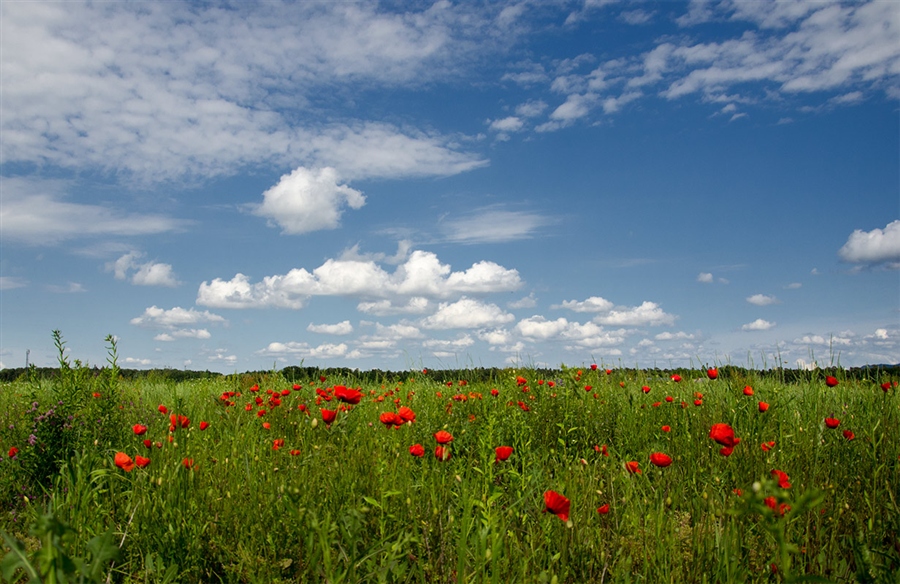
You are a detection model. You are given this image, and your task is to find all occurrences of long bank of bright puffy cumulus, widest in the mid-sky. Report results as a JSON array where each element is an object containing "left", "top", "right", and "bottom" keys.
[{"left": 197, "top": 250, "right": 522, "bottom": 314}]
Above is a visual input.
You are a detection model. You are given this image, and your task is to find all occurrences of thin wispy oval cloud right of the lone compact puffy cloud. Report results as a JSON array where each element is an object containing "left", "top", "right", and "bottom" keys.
[{"left": 441, "top": 208, "right": 557, "bottom": 244}]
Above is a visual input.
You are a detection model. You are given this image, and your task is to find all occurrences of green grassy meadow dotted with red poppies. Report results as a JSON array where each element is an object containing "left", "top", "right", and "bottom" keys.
[{"left": 0, "top": 334, "right": 900, "bottom": 583}]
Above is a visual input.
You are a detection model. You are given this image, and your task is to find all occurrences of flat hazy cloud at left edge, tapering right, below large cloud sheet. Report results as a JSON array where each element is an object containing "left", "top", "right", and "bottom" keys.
[{"left": 0, "top": 176, "right": 188, "bottom": 245}]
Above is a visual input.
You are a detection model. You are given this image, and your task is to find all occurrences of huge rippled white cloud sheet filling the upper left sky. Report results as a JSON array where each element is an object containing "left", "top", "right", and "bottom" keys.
[{"left": 0, "top": 2, "right": 492, "bottom": 181}]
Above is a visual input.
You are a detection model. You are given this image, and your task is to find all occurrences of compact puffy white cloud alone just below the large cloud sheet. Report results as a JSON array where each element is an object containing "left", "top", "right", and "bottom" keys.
[{"left": 253, "top": 166, "right": 366, "bottom": 235}]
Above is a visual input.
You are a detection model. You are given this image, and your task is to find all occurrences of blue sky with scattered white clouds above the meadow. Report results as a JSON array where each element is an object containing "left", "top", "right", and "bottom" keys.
[{"left": 0, "top": 0, "right": 900, "bottom": 372}]
